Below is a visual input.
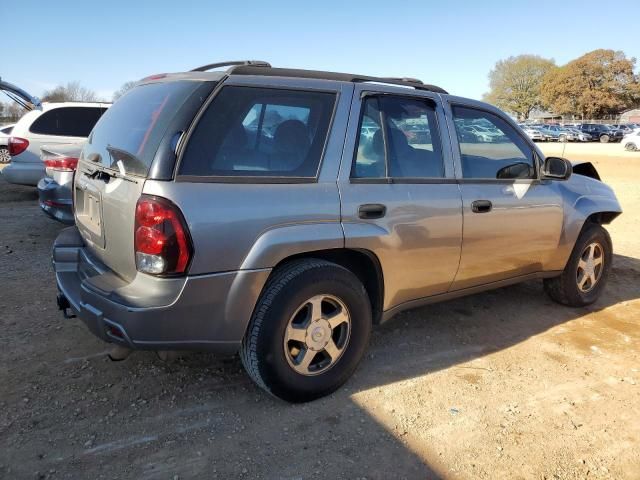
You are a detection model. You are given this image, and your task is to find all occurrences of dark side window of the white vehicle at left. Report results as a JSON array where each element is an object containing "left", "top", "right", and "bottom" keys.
[{"left": 30, "top": 107, "right": 106, "bottom": 137}]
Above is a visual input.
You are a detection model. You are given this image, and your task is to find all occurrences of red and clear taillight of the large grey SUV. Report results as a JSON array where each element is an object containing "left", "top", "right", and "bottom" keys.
[{"left": 134, "top": 195, "right": 193, "bottom": 275}]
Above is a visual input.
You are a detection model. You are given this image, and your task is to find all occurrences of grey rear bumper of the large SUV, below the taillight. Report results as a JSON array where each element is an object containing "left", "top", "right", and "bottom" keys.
[{"left": 53, "top": 227, "right": 270, "bottom": 354}]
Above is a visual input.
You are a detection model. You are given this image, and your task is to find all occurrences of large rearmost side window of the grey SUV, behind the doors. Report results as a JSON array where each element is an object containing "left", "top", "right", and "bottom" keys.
[{"left": 179, "top": 86, "right": 335, "bottom": 177}]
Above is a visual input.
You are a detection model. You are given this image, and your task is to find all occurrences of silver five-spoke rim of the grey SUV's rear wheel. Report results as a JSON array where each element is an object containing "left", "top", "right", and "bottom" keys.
[{"left": 284, "top": 295, "right": 351, "bottom": 376}]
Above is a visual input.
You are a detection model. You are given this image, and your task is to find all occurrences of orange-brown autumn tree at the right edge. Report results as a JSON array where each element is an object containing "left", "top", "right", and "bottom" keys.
[{"left": 542, "top": 49, "right": 640, "bottom": 118}]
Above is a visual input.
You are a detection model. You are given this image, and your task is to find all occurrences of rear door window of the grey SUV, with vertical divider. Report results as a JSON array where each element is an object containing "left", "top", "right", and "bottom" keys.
[{"left": 352, "top": 95, "right": 444, "bottom": 178}]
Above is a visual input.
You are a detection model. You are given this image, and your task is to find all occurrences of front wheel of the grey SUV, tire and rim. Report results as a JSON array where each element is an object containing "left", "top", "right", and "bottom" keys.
[{"left": 544, "top": 224, "right": 613, "bottom": 307}]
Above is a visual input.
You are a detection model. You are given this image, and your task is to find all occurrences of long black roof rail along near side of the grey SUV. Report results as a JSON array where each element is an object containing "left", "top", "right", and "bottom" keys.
[{"left": 227, "top": 64, "right": 448, "bottom": 94}]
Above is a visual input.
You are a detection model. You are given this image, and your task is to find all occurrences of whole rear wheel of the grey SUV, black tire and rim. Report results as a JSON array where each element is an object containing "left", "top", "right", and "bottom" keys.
[{"left": 240, "top": 259, "right": 371, "bottom": 402}]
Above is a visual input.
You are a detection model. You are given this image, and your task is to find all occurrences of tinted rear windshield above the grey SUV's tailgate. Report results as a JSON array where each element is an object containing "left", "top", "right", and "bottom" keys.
[{"left": 82, "top": 81, "right": 198, "bottom": 176}]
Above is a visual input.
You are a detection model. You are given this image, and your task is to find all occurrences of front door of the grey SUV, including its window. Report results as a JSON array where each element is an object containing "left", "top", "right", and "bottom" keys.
[{"left": 446, "top": 97, "right": 563, "bottom": 290}]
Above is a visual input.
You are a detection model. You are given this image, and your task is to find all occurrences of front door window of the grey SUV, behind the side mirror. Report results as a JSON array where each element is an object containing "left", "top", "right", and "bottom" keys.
[{"left": 453, "top": 107, "right": 536, "bottom": 179}]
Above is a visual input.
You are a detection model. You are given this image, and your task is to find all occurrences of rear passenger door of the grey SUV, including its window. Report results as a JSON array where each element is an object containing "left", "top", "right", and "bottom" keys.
[{"left": 338, "top": 84, "right": 462, "bottom": 310}]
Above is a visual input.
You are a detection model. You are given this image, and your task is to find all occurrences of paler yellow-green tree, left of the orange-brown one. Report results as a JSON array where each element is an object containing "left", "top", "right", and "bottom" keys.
[{"left": 484, "top": 55, "right": 556, "bottom": 119}]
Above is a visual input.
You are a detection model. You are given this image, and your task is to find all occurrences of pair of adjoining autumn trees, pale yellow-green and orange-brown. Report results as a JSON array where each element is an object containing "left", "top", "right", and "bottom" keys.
[{"left": 483, "top": 49, "right": 640, "bottom": 119}]
